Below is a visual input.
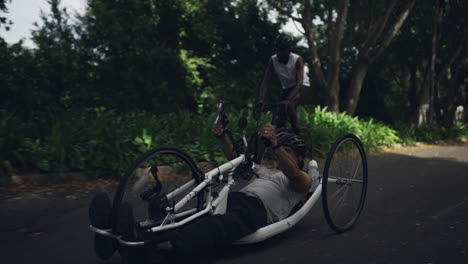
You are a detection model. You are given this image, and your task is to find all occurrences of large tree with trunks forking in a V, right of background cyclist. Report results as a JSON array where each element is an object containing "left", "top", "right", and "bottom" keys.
[{"left": 268, "top": 0, "right": 416, "bottom": 115}]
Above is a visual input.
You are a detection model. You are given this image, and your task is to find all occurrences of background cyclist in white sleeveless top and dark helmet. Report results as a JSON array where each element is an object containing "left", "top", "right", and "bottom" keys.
[{"left": 257, "top": 34, "right": 310, "bottom": 134}]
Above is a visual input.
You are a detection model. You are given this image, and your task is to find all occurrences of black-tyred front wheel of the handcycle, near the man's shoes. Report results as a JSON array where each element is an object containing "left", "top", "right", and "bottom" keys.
[{"left": 112, "top": 146, "right": 204, "bottom": 230}]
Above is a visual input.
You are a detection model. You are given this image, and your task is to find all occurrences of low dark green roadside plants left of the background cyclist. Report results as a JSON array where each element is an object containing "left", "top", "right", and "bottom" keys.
[{"left": 0, "top": 109, "right": 226, "bottom": 182}]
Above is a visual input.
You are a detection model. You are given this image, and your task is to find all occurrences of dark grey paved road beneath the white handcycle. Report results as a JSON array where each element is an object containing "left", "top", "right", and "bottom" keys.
[{"left": 0, "top": 144, "right": 468, "bottom": 264}]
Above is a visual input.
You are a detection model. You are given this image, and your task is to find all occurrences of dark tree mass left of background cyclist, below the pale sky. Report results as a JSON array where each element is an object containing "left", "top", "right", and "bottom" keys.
[{"left": 0, "top": 0, "right": 279, "bottom": 114}]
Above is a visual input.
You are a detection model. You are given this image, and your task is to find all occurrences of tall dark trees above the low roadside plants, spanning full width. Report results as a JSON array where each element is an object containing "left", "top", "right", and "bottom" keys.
[{"left": 0, "top": 0, "right": 467, "bottom": 123}]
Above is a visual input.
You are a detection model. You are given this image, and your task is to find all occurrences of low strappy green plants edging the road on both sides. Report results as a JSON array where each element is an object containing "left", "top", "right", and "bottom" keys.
[{"left": 0, "top": 107, "right": 468, "bottom": 182}]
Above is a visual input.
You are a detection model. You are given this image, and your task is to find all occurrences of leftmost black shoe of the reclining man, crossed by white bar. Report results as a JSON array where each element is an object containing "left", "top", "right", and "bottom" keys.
[{"left": 88, "top": 192, "right": 117, "bottom": 260}]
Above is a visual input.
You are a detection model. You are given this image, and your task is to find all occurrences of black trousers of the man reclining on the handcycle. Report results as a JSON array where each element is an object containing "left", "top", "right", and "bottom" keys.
[{"left": 170, "top": 192, "right": 267, "bottom": 254}]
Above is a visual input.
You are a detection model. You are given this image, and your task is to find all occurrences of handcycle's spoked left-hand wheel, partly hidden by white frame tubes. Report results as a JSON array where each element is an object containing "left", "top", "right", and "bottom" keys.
[{"left": 112, "top": 146, "right": 204, "bottom": 230}]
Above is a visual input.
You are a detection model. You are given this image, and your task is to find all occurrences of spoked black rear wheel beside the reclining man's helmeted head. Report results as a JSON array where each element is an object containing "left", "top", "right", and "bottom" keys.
[{"left": 322, "top": 134, "right": 368, "bottom": 233}]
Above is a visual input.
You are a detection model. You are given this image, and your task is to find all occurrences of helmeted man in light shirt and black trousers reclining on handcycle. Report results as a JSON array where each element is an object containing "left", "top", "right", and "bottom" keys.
[{"left": 90, "top": 122, "right": 312, "bottom": 262}]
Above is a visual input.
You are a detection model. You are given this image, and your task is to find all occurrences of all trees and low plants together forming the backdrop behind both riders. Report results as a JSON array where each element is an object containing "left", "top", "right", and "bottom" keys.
[{"left": 0, "top": 0, "right": 468, "bottom": 179}]
